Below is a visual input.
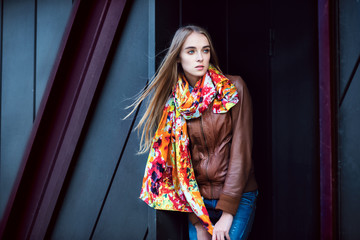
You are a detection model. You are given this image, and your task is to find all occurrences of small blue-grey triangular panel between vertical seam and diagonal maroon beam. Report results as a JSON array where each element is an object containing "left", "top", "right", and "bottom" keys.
[{"left": 35, "top": 0, "right": 72, "bottom": 111}]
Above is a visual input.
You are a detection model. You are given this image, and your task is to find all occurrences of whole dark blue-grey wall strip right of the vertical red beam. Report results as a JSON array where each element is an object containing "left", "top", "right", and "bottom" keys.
[{"left": 337, "top": 0, "right": 360, "bottom": 240}]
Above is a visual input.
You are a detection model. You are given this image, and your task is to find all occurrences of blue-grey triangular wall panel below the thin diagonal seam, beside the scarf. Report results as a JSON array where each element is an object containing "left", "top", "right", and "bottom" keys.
[{"left": 94, "top": 126, "right": 149, "bottom": 240}]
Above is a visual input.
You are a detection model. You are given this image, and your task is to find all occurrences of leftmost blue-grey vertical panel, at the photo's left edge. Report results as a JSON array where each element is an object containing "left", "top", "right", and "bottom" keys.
[{"left": 0, "top": 0, "right": 35, "bottom": 219}]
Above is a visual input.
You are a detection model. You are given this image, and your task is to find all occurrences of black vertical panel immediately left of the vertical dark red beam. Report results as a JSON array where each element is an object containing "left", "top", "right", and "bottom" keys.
[{"left": 271, "top": 0, "right": 320, "bottom": 240}]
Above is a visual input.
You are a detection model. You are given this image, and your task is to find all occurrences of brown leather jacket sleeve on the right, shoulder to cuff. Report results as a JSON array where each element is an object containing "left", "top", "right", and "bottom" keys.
[{"left": 216, "top": 76, "right": 253, "bottom": 215}]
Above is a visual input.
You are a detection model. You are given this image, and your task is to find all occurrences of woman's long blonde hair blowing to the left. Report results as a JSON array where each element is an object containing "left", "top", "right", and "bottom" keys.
[{"left": 127, "top": 25, "right": 220, "bottom": 153}]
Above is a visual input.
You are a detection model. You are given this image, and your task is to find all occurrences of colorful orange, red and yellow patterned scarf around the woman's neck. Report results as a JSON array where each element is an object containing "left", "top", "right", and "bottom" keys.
[{"left": 140, "top": 66, "right": 239, "bottom": 234}]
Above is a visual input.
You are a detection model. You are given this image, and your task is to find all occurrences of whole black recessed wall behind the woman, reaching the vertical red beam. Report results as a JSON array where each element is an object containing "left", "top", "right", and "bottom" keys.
[{"left": 156, "top": 0, "right": 320, "bottom": 239}]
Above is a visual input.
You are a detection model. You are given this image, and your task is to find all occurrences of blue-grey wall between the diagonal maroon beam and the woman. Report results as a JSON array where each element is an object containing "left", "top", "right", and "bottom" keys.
[{"left": 51, "top": 0, "right": 154, "bottom": 239}]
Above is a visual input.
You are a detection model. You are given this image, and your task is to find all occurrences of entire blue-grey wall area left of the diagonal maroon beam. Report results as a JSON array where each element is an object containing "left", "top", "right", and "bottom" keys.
[{"left": 0, "top": 0, "right": 72, "bottom": 219}]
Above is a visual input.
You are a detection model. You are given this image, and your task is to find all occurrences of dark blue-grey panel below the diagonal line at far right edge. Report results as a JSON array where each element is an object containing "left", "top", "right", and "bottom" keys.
[{"left": 339, "top": 67, "right": 360, "bottom": 240}]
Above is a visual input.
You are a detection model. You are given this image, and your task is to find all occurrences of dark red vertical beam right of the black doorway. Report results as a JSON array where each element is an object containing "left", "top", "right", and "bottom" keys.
[{"left": 318, "top": 0, "right": 335, "bottom": 240}]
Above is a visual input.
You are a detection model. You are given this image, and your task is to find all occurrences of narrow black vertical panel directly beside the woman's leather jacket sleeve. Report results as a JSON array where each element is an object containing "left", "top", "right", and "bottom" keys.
[{"left": 228, "top": 0, "right": 273, "bottom": 239}]
